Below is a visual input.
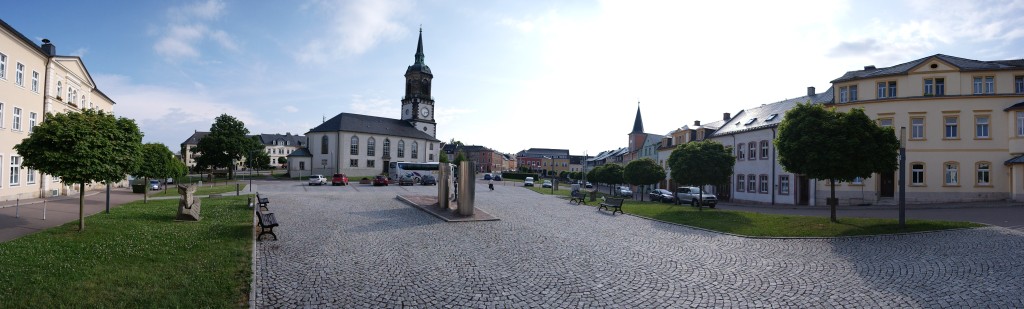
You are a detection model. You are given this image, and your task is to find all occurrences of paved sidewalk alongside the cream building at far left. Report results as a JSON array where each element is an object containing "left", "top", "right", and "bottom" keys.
[{"left": 0, "top": 188, "right": 146, "bottom": 242}]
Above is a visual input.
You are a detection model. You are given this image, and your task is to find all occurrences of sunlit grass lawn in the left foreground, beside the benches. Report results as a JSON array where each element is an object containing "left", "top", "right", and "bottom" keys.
[{"left": 0, "top": 195, "right": 253, "bottom": 308}]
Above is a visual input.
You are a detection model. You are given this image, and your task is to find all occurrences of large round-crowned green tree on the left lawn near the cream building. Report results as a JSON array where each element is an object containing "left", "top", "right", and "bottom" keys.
[{"left": 14, "top": 109, "right": 142, "bottom": 231}]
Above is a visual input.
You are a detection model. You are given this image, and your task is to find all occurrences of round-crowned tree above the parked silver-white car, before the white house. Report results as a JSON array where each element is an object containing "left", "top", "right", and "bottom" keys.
[{"left": 669, "top": 139, "right": 736, "bottom": 207}]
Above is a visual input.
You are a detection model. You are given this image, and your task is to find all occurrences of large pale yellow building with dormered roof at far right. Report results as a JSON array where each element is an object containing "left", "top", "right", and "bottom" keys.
[{"left": 816, "top": 54, "right": 1024, "bottom": 205}]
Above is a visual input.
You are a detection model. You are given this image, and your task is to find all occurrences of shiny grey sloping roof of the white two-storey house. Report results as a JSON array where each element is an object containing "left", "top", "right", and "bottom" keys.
[{"left": 711, "top": 87, "right": 833, "bottom": 137}]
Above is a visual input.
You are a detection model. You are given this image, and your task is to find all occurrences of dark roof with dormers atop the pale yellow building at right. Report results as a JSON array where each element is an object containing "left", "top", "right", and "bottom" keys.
[{"left": 831, "top": 53, "right": 1024, "bottom": 84}]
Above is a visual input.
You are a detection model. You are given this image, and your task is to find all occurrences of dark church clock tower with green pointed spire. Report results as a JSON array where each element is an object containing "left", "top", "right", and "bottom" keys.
[{"left": 401, "top": 28, "right": 437, "bottom": 137}]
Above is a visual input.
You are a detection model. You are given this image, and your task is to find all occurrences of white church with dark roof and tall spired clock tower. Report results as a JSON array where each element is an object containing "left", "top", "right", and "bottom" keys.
[{"left": 299, "top": 29, "right": 440, "bottom": 177}]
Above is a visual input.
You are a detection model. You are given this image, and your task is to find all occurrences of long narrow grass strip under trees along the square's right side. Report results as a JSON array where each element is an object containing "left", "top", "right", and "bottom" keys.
[{"left": 534, "top": 187, "right": 984, "bottom": 237}]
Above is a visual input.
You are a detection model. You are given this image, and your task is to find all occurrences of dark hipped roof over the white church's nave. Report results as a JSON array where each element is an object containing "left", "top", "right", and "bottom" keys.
[{"left": 306, "top": 113, "right": 438, "bottom": 141}]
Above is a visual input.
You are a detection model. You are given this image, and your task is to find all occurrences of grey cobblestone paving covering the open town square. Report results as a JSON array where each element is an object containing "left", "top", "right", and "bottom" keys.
[{"left": 252, "top": 182, "right": 1024, "bottom": 308}]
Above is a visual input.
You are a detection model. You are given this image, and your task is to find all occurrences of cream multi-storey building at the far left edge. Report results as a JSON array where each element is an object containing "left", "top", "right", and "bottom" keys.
[{"left": 0, "top": 20, "right": 114, "bottom": 200}]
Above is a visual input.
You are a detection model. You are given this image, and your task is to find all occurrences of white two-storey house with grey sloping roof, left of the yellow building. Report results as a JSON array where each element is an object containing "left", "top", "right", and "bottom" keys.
[{"left": 710, "top": 87, "right": 833, "bottom": 205}]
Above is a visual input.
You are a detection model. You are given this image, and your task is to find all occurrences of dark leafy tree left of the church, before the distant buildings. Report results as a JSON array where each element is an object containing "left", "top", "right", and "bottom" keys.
[{"left": 193, "top": 114, "right": 262, "bottom": 179}]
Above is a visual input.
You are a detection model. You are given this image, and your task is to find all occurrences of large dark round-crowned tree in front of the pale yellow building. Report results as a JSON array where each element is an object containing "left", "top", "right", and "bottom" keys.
[{"left": 775, "top": 102, "right": 899, "bottom": 222}]
